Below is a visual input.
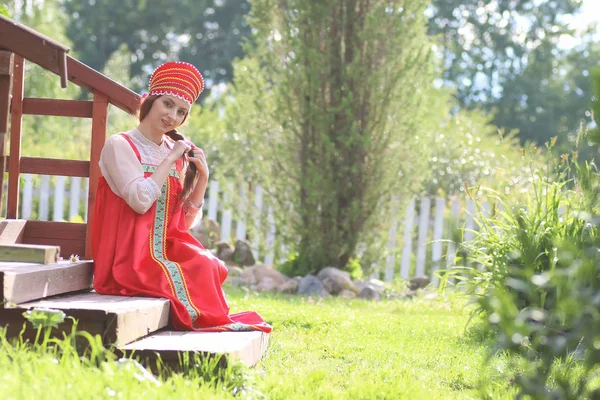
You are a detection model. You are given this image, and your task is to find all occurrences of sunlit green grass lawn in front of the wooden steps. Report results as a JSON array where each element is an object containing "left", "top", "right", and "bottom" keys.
[{"left": 0, "top": 288, "right": 515, "bottom": 400}]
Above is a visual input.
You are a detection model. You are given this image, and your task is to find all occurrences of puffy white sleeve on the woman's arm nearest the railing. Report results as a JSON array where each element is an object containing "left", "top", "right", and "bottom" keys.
[{"left": 100, "top": 135, "right": 160, "bottom": 214}]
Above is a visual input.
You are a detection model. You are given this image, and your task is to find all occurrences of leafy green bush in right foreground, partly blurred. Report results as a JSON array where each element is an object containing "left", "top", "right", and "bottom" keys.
[{"left": 457, "top": 71, "right": 600, "bottom": 399}]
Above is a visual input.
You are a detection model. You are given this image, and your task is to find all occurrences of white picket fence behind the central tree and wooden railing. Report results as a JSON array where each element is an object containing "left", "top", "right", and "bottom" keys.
[{"left": 10, "top": 174, "right": 490, "bottom": 282}]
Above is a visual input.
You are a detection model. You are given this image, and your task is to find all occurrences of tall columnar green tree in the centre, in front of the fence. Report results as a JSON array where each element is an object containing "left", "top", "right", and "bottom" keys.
[{"left": 226, "top": 0, "right": 434, "bottom": 274}]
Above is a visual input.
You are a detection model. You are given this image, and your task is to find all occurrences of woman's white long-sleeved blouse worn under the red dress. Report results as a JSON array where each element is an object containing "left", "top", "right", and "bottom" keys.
[{"left": 99, "top": 128, "right": 202, "bottom": 229}]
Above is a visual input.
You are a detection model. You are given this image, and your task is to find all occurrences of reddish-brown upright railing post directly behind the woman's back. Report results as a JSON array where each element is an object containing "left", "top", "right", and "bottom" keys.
[{"left": 85, "top": 92, "right": 108, "bottom": 260}]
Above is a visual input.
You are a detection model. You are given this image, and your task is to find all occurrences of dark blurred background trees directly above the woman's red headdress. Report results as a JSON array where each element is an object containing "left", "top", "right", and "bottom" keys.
[{"left": 64, "top": 0, "right": 249, "bottom": 95}]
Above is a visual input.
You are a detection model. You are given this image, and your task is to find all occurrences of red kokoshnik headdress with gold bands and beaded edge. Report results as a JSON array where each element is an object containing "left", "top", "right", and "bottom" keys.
[{"left": 148, "top": 61, "right": 204, "bottom": 105}]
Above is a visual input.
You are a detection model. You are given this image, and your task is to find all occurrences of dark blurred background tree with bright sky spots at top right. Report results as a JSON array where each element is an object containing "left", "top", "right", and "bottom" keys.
[{"left": 429, "top": 0, "right": 597, "bottom": 144}]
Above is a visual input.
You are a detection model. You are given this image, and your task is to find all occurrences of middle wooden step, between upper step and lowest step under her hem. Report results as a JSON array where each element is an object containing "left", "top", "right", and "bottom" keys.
[{"left": 0, "top": 292, "right": 170, "bottom": 346}]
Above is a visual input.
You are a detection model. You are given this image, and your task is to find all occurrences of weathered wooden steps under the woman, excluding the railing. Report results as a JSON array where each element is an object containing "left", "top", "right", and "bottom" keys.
[{"left": 0, "top": 261, "right": 269, "bottom": 369}]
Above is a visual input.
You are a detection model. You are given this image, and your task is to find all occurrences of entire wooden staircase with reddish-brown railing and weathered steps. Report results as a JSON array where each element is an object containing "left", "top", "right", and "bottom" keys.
[{"left": 0, "top": 15, "right": 269, "bottom": 372}]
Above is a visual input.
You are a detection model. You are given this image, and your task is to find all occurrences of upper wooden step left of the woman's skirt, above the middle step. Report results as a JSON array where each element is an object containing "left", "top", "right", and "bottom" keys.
[{"left": 0, "top": 261, "right": 94, "bottom": 308}]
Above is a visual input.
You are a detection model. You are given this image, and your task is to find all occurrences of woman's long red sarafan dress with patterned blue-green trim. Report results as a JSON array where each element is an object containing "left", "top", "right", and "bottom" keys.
[{"left": 92, "top": 129, "right": 271, "bottom": 332}]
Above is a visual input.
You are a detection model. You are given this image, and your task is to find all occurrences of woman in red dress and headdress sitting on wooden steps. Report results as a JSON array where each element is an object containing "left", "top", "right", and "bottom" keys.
[{"left": 92, "top": 62, "right": 271, "bottom": 332}]
